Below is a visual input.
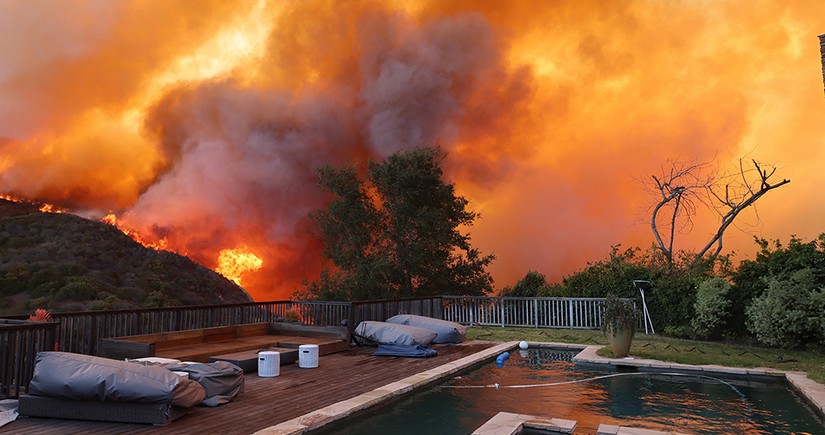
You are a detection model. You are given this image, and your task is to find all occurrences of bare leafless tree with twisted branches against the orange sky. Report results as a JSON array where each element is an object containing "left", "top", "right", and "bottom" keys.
[{"left": 647, "top": 159, "right": 791, "bottom": 267}]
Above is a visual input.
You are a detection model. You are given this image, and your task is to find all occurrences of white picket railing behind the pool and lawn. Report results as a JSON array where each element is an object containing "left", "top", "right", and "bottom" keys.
[{"left": 442, "top": 296, "right": 604, "bottom": 329}]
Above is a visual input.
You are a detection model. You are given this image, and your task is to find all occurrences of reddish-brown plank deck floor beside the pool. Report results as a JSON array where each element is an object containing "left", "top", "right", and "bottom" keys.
[{"left": 0, "top": 341, "right": 496, "bottom": 435}]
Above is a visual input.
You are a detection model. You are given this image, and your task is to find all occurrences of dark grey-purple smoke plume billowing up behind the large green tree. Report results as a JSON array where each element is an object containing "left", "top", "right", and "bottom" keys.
[{"left": 124, "top": 5, "right": 524, "bottom": 296}]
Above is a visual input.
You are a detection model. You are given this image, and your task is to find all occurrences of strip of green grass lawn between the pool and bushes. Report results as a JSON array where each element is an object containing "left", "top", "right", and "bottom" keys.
[{"left": 467, "top": 326, "right": 825, "bottom": 384}]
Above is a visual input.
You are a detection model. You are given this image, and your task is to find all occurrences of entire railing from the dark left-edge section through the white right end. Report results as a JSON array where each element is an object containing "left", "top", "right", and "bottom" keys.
[{"left": 0, "top": 296, "right": 620, "bottom": 398}]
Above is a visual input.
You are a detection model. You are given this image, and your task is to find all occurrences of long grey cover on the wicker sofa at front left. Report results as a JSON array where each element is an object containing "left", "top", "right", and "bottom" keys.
[{"left": 29, "top": 352, "right": 205, "bottom": 408}]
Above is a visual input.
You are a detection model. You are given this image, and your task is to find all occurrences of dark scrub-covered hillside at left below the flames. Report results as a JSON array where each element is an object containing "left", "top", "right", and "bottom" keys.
[{"left": 0, "top": 199, "right": 252, "bottom": 315}]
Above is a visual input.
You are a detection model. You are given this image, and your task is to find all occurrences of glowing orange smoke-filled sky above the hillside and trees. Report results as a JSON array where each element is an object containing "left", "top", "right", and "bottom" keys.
[{"left": 0, "top": 0, "right": 825, "bottom": 300}]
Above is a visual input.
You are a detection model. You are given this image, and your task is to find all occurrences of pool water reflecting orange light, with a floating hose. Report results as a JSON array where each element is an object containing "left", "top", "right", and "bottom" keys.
[{"left": 324, "top": 349, "right": 825, "bottom": 435}]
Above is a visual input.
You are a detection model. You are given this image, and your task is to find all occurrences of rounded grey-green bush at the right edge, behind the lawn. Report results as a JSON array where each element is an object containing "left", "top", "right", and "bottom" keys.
[{"left": 747, "top": 269, "right": 825, "bottom": 348}]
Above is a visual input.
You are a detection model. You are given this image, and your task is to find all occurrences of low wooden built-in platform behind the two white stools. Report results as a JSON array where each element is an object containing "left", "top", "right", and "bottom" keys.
[{"left": 97, "top": 322, "right": 350, "bottom": 362}]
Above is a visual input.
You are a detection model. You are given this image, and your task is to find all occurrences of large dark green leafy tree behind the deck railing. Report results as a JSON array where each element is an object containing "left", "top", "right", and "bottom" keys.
[{"left": 303, "top": 147, "right": 494, "bottom": 300}]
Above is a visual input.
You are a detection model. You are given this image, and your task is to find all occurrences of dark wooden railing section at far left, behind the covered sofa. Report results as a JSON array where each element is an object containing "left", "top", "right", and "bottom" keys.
[{"left": 0, "top": 319, "right": 57, "bottom": 399}]
